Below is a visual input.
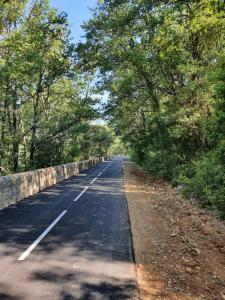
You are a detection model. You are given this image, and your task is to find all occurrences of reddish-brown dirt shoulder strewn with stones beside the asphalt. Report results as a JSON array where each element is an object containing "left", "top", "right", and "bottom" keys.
[{"left": 124, "top": 162, "right": 225, "bottom": 300}]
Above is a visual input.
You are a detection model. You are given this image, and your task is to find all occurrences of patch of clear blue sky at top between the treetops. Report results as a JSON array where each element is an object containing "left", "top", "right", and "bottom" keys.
[{"left": 49, "top": 0, "right": 97, "bottom": 42}]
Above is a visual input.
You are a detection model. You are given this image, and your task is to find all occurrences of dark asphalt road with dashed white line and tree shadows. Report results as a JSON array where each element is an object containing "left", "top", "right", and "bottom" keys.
[{"left": 0, "top": 159, "right": 138, "bottom": 300}]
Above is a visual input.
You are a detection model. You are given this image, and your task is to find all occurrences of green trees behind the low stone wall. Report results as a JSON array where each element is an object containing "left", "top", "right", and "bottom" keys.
[{"left": 0, "top": 0, "right": 114, "bottom": 175}]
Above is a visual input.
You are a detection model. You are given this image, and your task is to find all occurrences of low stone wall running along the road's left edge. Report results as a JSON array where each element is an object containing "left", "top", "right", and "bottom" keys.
[{"left": 0, "top": 157, "right": 107, "bottom": 209}]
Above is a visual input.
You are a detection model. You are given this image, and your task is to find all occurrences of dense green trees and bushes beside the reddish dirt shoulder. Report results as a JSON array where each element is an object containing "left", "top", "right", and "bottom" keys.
[{"left": 78, "top": 0, "right": 225, "bottom": 216}]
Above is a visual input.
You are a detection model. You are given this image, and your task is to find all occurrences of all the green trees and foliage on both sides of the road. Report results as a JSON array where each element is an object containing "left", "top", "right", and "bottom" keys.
[{"left": 0, "top": 0, "right": 225, "bottom": 217}]
